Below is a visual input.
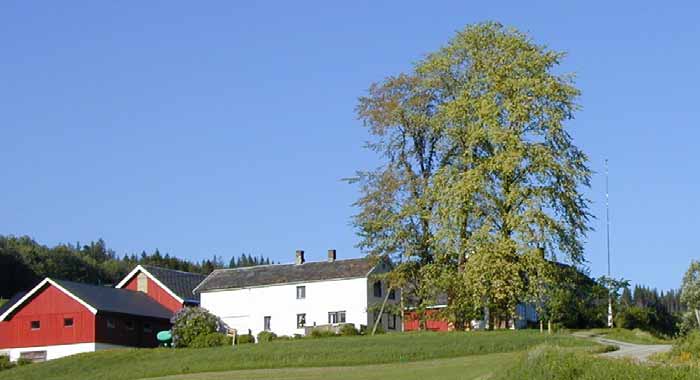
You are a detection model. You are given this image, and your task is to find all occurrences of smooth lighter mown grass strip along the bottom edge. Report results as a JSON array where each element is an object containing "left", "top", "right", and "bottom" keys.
[{"left": 150, "top": 352, "right": 518, "bottom": 380}]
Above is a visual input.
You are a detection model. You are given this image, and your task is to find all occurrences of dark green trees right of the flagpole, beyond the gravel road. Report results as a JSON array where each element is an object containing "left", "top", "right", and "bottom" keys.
[{"left": 615, "top": 285, "right": 687, "bottom": 337}]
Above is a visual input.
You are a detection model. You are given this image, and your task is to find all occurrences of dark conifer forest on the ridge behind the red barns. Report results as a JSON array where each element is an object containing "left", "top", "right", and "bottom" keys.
[{"left": 0, "top": 235, "right": 273, "bottom": 298}]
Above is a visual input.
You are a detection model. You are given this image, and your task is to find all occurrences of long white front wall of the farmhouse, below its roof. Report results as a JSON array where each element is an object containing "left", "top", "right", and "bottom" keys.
[{"left": 201, "top": 278, "right": 378, "bottom": 336}]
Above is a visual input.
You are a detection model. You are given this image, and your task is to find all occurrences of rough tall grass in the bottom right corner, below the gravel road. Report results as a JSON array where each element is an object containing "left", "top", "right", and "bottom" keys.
[{"left": 494, "top": 345, "right": 698, "bottom": 380}]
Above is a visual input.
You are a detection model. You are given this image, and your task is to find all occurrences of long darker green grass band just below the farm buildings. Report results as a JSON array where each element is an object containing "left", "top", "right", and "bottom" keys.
[{"left": 0, "top": 331, "right": 595, "bottom": 380}]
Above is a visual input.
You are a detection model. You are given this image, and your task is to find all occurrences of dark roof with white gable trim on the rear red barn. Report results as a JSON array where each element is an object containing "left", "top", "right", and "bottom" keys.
[{"left": 116, "top": 265, "right": 207, "bottom": 302}]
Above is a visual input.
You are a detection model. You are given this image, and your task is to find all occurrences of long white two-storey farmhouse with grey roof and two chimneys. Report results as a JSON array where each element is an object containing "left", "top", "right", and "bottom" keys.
[{"left": 195, "top": 250, "right": 401, "bottom": 336}]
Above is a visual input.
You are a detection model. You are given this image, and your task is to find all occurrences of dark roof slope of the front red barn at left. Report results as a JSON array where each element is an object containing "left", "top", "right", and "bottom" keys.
[{"left": 55, "top": 280, "right": 173, "bottom": 319}]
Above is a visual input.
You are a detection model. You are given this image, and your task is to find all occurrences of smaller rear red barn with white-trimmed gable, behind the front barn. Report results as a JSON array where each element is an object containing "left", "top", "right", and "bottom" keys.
[{"left": 116, "top": 265, "right": 207, "bottom": 312}]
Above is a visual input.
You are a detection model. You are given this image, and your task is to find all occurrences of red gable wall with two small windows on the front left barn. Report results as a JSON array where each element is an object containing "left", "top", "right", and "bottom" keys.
[{"left": 0, "top": 284, "right": 95, "bottom": 348}]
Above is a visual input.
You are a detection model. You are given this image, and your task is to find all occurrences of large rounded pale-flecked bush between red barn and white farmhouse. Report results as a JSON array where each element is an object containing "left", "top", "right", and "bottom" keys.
[{"left": 170, "top": 307, "right": 227, "bottom": 347}]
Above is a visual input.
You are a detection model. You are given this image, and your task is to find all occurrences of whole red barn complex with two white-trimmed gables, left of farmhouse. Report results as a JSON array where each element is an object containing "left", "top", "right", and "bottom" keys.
[{"left": 0, "top": 265, "right": 205, "bottom": 361}]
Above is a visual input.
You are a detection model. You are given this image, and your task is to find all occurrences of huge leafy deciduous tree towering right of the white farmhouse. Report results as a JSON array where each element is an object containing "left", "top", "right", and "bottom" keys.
[{"left": 354, "top": 23, "right": 590, "bottom": 324}]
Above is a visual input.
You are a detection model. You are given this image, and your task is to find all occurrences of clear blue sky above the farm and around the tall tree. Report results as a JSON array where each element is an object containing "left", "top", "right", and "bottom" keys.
[{"left": 0, "top": 1, "right": 700, "bottom": 289}]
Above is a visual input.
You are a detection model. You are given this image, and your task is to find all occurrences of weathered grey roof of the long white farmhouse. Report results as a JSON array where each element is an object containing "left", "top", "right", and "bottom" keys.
[{"left": 196, "top": 258, "right": 374, "bottom": 293}]
